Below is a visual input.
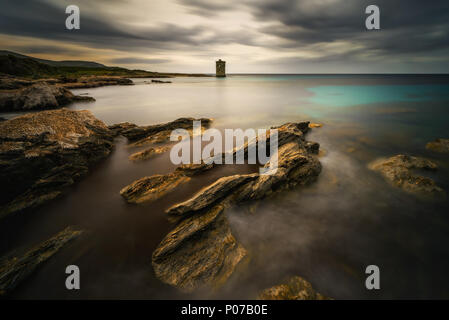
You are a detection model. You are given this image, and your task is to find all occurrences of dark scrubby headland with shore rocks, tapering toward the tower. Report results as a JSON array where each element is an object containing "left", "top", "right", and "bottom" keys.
[{"left": 0, "top": 51, "right": 209, "bottom": 112}]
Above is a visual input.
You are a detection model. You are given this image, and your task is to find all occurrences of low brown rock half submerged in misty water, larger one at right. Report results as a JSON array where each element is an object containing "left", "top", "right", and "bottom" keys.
[{"left": 369, "top": 154, "right": 445, "bottom": 196}]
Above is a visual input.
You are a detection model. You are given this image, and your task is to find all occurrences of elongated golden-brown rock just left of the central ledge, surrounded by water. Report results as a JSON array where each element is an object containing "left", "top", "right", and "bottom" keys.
[{"left": 120, "top": 173, "right": 190, "bottom": 203}]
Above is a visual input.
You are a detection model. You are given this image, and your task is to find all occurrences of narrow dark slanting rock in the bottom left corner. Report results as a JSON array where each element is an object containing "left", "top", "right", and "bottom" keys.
[{"left": 0, "top": 227, "right": 82, "bottom": 296}]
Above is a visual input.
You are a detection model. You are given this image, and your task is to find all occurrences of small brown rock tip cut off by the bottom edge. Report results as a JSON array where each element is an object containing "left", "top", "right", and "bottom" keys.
[{"left": 259, "top": 276, "right": 329, "bottom": 300}]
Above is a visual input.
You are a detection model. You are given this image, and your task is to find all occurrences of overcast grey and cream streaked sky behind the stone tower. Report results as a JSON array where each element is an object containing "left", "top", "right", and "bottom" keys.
[{"left": 0, "top": 0, "right": 449, "bottom": 73}]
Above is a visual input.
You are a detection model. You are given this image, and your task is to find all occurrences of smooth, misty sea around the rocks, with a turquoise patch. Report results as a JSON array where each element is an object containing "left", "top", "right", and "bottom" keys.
[{"left": 0, "top": 75, "right": 449, "bottom": 299}]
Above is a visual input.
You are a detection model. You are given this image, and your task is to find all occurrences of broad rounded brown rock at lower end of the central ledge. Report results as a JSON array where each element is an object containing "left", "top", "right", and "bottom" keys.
[{"left": 152, "top": 205, "right": 246, "bottom": 291}]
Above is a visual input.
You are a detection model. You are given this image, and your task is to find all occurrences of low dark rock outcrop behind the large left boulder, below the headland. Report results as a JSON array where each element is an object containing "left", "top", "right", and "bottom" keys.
[{"left": 0, "top": 82, "right": 95, "bottom": 111}]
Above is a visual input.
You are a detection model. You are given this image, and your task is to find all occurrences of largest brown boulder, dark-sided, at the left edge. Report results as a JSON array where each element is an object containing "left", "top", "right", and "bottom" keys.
[{"left": 0, "top": 109, "right": 113, "bottom": 219}]
